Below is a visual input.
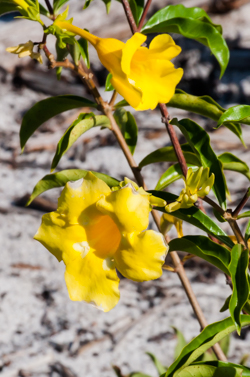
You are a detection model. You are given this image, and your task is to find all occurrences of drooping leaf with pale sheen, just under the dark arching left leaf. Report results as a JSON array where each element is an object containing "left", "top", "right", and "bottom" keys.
[{"left": 51, "top": 113, "right": 110, "bottom": 171}]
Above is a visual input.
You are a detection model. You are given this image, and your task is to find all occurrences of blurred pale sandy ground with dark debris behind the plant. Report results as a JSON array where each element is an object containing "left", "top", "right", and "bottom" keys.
[{"left": 0, "top": 0, "right": 250, "bottom": 377}]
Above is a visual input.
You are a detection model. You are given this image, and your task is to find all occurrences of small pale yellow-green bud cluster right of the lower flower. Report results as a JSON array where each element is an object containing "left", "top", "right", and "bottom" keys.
[{"left": 165, "top": 167, "right": 214, "bottom": 212}]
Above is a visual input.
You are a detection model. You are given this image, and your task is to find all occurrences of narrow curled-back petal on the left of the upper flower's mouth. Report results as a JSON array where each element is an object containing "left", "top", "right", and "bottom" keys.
[{"left": 121, "top": 33, "right": 147, "bottom": 75}]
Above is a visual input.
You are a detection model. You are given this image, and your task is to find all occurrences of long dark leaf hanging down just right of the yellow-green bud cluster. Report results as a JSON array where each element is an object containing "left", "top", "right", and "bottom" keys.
[{"left": 171, "top": 118, "right": 227, "bottom": 209}]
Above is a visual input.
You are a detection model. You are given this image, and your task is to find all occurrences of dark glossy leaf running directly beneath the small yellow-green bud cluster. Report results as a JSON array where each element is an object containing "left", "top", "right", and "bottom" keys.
[{"left": 149, "top": 190, "right": 234, "bottom": 248}]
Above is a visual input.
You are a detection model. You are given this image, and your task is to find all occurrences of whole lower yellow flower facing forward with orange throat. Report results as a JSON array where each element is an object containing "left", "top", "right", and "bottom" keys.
[{"left": 34, "top": 173, "right": 167, "bottom": 312}]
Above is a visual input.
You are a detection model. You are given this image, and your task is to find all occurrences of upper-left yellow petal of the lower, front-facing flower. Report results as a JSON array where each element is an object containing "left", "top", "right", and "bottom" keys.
[{"left": 57, "top": 172, "right": 111, "bottom": 224}]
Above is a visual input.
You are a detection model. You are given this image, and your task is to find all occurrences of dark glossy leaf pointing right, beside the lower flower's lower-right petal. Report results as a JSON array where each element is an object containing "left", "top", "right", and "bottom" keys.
[{"left": 169, "top": 236, "right": 231, "bottom": 275}]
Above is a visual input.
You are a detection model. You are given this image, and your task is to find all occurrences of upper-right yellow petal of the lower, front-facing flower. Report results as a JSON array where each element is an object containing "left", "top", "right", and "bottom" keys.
[{"left": 96, "top": 184, "right": 150, "bottom": 232}]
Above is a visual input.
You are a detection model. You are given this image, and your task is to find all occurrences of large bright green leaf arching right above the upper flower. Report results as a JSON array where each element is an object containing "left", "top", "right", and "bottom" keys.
[{"left": 142, "top": 4, "right": 229, "bottom": 77}]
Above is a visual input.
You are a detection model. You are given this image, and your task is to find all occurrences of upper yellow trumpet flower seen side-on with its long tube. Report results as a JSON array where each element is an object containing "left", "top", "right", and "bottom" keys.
[{"left": 54, "top": 18, "right": 183, "bottom": 110}]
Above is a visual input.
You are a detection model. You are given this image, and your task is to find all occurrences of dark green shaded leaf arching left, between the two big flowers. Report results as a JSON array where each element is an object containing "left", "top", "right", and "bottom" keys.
[{"left": 20, "top": 95, "right": 97, "bottom": 150}]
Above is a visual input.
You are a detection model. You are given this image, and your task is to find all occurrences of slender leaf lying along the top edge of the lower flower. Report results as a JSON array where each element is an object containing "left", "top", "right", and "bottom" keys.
[{"left": 26, "top": 169, "right": 119, "bottom": 206}]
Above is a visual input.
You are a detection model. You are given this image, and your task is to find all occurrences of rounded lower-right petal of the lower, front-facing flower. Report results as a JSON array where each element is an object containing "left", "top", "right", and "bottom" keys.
[{"left": 115, "top": 230, "right": 168, "bottom": 281}]
